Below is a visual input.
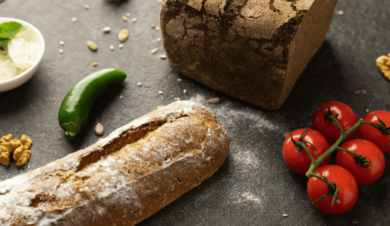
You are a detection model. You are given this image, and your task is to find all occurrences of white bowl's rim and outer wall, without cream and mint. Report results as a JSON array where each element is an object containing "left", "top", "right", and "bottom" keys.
[{"left": 0, "top": 17, "right": 45, "bottom": 92}]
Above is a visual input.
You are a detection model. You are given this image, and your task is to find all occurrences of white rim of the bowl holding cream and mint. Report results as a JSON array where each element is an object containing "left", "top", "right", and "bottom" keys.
[{"left": 0, "top": 17, "right": 46, "bottom": 85}]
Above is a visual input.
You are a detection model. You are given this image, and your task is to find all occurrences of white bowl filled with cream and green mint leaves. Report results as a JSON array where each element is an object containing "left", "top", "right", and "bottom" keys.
[{"left": 0, "top": 18, "right": 45, "bottom": 92}]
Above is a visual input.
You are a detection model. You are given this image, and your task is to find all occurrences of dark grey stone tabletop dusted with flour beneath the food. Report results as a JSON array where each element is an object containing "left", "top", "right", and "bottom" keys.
[{"left": 0, "top": 0, "right": 390, "bottom": 226}]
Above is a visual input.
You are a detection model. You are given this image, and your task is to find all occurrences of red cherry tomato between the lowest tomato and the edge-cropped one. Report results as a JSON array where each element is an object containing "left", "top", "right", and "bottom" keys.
[{"left": 336, "top": 139, "right": 386, "bottom": 185}]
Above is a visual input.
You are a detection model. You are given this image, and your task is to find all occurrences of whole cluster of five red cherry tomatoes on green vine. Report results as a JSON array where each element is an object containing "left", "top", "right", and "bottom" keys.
[{"left": 282, "top": 101, "right": 390, "bottom": 215}]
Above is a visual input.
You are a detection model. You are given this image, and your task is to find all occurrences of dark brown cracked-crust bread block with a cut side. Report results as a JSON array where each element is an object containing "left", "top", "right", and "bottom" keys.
[{"left": 160, "top": 0, "right": 337, "bottom": 110}]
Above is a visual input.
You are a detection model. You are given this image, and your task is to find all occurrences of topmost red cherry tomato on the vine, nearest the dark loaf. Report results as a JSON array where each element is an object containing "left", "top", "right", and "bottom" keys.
[{"left": 313, "top": 101, "right": 358, "bottom": 144}]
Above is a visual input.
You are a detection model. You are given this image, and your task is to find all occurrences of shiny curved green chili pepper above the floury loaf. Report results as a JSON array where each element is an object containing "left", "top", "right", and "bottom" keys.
[{"left": 58, "top": 68, "right": 126, "bottom": 139}]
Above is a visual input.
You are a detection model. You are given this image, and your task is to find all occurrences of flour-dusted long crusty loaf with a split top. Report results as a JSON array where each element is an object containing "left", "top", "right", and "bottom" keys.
[{"left": 0, "top": 101, "right": 230, "bottom": 226}]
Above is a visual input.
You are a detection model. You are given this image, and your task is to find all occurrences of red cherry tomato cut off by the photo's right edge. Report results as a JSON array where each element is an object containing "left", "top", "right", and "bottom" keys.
[{"left": 358, "top": 111, "right": 390, "bottom": 154}]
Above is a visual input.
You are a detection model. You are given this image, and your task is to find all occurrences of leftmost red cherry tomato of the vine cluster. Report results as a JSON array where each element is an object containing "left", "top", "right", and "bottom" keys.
[{"left": 282, "top": 129, "right": 330, "bottom": 175}]
